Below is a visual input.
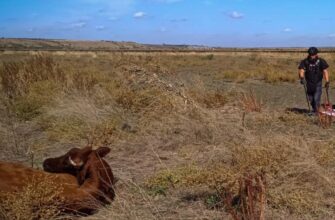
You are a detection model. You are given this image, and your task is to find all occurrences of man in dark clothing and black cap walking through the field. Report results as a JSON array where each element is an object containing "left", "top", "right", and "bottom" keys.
[{"left": 298, "top": 47, "right": 329, "bottom": 112}]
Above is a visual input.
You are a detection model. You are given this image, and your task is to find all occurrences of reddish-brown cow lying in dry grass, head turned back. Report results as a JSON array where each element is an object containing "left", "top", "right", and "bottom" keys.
[{"left": 0, "top": 147, "right": 115, "bottom": 214}]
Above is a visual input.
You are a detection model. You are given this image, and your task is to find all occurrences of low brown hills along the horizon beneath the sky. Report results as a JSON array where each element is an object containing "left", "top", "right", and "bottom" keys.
[{"left": 0, "top": 38, "right": 335, "bottom": 52}]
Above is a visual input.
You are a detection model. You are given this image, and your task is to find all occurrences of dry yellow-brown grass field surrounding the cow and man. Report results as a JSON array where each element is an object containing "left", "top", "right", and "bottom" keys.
[{"left": 0, "top": 51, "right": 335, "bottom": 220}]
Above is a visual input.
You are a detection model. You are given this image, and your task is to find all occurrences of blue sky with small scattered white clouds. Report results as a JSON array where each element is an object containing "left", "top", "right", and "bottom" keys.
[{"left": 0, "top": 0, "right": 335, "bottom": 47}]
